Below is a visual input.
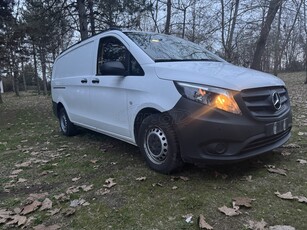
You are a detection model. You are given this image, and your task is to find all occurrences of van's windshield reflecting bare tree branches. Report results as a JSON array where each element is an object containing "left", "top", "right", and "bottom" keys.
[{"left": 125, "top": 32, "right": 222, "bottom": 62}]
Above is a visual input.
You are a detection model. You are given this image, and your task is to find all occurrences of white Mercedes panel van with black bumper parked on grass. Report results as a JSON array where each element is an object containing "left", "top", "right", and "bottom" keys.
[{"left": 51, "top": 30, "right": 292, "bottom": 173}]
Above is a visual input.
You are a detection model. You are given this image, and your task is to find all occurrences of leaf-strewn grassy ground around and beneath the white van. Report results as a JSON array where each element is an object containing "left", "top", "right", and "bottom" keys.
[{"left": 0, "top": 73, "right": 307, "bottom": 230}]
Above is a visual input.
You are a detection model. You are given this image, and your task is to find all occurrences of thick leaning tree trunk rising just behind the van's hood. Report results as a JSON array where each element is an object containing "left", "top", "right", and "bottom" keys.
[{"left": 251, "top": 0, "right": 282, "bottom": 70}]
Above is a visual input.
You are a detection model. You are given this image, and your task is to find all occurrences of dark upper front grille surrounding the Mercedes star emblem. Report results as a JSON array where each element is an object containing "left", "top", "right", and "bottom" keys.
[{"left": 240, "top": 87, "right": 290, "bottom": 120}]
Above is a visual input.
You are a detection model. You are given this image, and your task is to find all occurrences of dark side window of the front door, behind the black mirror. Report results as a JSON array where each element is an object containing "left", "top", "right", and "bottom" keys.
[{"left": 97, "top": 37, "right": 144, "bottom": 76}]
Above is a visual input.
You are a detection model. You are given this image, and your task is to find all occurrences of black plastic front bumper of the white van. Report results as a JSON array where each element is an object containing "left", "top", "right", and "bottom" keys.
[{"left": 168, "top": 97, "right": 292, "bottom": 164}]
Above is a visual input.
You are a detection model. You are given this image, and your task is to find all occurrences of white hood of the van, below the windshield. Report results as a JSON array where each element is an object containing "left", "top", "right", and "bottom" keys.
[{"left": 155, "top": 62, "right": 285, "bottom": 91}]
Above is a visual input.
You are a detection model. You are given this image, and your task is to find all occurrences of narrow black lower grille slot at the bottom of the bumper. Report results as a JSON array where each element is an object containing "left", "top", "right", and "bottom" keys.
[{"left": 241, "top": 128, "right": 291, "bottom": 153}]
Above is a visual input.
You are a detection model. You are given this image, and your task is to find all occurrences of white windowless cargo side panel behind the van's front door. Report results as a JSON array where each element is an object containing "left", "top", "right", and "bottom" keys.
[{"left": 52, "top": 40, "right": 96, "bottom": 124}]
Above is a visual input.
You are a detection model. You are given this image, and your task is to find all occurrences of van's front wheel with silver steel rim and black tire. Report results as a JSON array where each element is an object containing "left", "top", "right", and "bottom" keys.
[{"left": 138, "top": 114, "right": 183, "bottom": 174}]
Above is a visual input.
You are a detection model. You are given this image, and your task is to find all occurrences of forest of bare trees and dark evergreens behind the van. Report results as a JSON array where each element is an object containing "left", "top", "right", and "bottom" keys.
[{"left": 0, "top": 0, "right": 307, "bottom": 103}]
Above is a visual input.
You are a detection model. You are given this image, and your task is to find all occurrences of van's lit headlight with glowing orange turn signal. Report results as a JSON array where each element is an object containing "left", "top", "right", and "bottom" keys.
[{"left": 175, "top": 82, "right": 241, "bottom": 114}]
